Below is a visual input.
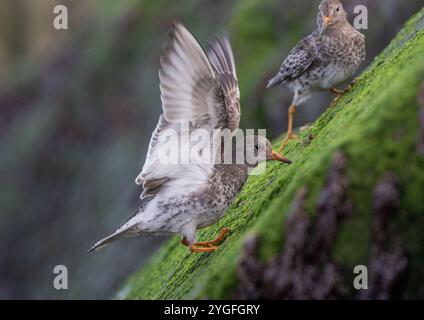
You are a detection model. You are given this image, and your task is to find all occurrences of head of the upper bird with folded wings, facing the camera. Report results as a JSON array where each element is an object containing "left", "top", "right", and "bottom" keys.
[{"left": 317, "top": 0, "right": 347, "bottom": 38}]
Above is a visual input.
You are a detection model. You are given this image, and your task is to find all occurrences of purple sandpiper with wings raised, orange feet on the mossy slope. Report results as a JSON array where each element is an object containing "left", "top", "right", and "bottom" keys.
[{"left": 90, "top": 23, "right": 290, "bottom": 252}]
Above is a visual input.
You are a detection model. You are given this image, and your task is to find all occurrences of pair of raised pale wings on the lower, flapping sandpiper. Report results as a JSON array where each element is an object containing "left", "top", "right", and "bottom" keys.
[{"left": 136, "top": 23, "right": 240, "bottom": 198}]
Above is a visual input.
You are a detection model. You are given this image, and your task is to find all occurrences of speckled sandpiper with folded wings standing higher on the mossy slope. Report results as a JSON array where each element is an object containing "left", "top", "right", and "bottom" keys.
[{"left": 267, "top": 0, "right": 365, "bottom": 152}]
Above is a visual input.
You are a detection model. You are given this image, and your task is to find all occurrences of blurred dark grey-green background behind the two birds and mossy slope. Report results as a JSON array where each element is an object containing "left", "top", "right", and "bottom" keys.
[{"left": 0, "top": 0, "right": 423, "bottom": 299}]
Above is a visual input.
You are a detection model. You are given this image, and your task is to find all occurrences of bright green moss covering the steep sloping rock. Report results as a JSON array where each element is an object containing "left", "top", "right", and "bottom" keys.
[{"left": 118, "top": 6, "right": 424, "bottom": 299}]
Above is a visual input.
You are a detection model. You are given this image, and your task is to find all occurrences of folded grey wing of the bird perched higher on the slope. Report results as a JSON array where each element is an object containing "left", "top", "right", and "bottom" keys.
[{"left": 267, "top": 34, "right": 317, "bottom": 88}]
